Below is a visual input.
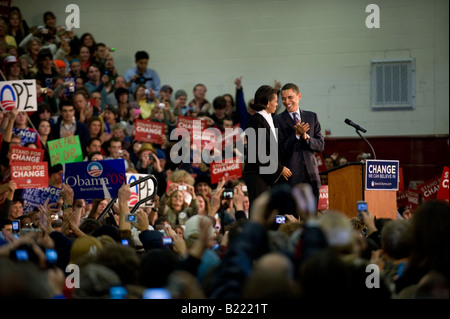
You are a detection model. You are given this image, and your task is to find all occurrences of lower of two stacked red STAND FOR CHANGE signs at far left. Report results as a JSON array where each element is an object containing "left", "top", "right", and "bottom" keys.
[{"left": 11, "top": 162, "right": 48, "bottom": 189}]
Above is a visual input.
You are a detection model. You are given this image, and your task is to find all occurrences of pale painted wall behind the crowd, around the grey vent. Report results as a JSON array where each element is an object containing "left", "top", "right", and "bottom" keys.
[{"left": 13, "top": 0, "right": 449, "bottom": 137}]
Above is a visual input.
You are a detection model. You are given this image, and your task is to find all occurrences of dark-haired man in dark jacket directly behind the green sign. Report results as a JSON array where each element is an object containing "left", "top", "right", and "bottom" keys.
[{"left": 52, "top": 101, "right": 90, "bottom": 156}]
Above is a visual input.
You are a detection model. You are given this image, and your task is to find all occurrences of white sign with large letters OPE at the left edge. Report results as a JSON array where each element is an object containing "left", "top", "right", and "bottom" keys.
[{"left": 0, "top": 80, "right": 37, "bottom": 112}]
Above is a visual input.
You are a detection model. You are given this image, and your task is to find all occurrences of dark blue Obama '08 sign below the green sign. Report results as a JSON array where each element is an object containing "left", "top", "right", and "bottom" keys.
[{"left": 64, "top": 158, "right": 126, "bottom": 199}]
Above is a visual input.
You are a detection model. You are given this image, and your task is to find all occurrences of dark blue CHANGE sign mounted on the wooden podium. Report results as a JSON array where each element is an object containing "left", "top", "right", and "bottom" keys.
[{"left": 366, "top": 160, "right": 399, "bottom": 190}]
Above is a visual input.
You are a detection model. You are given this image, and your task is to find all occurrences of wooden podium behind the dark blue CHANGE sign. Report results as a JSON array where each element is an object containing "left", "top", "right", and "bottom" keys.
[{"left": 321, "top": 162, "right": 397, "bottom": 219}]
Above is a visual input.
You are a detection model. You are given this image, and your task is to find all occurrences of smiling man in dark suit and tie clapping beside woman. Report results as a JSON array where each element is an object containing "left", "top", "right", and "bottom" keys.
[{"left": 274, "top": 83, "right": 325, "bottom": 209}]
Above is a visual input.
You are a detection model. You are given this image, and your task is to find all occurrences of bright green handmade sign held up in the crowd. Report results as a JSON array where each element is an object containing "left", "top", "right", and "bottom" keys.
[{"left": 47, "top": 135, "right": 83, "bottom": 166}]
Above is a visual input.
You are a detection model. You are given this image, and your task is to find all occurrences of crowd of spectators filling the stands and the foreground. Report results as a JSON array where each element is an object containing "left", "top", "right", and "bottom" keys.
[{"left": 0, "top": 7, "right": 449, "bottom": 299}]
